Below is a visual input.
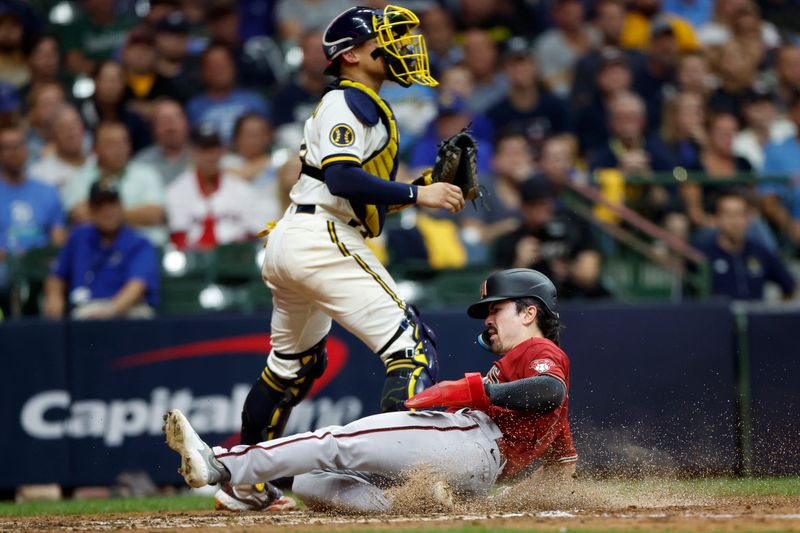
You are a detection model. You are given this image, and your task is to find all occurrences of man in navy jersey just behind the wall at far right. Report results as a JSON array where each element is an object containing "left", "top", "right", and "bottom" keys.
[{"left": 695, "top": 190, "right": 796, "bottom": 300}]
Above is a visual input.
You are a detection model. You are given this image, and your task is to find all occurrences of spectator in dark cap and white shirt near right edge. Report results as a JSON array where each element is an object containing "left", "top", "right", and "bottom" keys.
[{"left": 733, "top": 84, "right": 797, "bottom": 169}]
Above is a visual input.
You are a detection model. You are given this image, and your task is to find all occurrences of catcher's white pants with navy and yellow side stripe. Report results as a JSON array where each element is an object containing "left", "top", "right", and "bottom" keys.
[{"left": 262, "top": 205, "right": 416, "bottom": 379}]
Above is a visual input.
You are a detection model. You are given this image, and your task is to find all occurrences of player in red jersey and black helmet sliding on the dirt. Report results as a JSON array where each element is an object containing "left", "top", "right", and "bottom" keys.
[{"left": 164, "top": 269, "right": 577, "bottom": 512}]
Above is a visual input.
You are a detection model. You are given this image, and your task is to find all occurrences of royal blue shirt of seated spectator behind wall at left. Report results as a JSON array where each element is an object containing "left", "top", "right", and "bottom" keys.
[{"left": 52, "top": 224, "right": 159, "bottom": 307}]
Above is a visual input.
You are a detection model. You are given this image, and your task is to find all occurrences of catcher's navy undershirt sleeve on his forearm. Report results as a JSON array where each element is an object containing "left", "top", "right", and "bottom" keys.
[{"left": 323, "top": 163, "right": 417, "bottom": 205}]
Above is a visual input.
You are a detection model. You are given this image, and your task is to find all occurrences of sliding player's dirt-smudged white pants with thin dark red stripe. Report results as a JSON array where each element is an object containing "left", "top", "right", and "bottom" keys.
[{"left": 214, "top": 409, "right": 503, "bottom": 510}]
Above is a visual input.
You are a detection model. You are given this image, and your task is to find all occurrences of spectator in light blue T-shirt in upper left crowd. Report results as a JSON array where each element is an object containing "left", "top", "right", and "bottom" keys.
[{"left": 186, "top": 43, "right": 268, "bottom": 144}]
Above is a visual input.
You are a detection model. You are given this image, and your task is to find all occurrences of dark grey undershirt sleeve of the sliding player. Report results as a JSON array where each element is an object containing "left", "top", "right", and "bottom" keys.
[{"left": 485, "top": 376, "right": 567, "bottom": 414}]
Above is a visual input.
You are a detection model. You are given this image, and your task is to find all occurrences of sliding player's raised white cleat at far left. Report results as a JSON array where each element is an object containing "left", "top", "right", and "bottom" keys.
[{"left": 162, "top": 409, "right": 231, "bottom": 488}]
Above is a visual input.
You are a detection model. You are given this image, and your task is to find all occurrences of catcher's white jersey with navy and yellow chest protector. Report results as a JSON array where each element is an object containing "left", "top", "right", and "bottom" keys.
[{"left": 290, "top": 80, "right": 398, "bottom": 236}]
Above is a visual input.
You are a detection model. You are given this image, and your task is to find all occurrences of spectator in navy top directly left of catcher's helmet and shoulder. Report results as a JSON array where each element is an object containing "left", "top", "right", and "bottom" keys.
[{"left": 272, "top": 31, "right": 330, "bottom": 131}]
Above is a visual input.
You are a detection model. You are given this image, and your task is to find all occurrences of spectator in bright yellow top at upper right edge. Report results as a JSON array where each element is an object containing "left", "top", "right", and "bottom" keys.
[{"left": 620, "top": 0, "right": 700, "bottom": 53}]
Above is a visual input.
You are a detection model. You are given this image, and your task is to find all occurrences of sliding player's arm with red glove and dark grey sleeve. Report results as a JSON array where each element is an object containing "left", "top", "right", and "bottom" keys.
[{"left": 405, "top": 372, "right": 567, "bottom": 414}]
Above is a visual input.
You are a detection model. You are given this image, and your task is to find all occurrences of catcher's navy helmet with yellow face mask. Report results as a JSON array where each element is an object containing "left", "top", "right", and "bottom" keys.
[{"left": 322, "top": 5, "right": 439, "bottom": 87}]
